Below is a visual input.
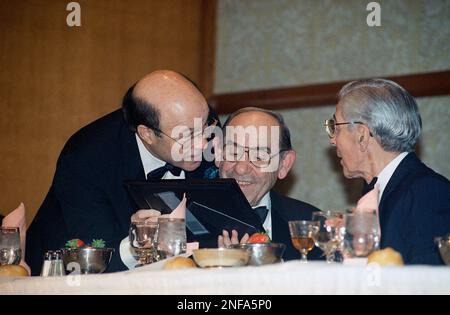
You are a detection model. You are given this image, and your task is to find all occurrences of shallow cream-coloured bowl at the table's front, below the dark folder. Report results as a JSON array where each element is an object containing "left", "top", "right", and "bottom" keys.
[{"left": 193, "top": 248, "right": 250, "bottom": 268}]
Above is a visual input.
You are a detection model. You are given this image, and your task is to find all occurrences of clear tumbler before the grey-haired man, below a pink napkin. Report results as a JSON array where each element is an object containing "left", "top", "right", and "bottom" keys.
[{"left": 344, "top": 210, "right": 380, "bottom": 258}]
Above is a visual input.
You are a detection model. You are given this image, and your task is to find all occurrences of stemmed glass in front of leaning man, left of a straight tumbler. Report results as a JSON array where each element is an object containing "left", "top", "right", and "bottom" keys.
[{"left": 129, "top": 221, "right": 158, "bottom": 267}]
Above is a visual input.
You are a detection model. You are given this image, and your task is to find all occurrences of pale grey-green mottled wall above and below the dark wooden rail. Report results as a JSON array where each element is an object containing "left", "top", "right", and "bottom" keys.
[{"left": 215, "top": 0, "right": 450, "bottom": 209}]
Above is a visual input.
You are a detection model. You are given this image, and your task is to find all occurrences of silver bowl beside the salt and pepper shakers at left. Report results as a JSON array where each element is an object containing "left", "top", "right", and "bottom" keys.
[{"left": 61, "top": 248, "right": 114, "bottom": 274}]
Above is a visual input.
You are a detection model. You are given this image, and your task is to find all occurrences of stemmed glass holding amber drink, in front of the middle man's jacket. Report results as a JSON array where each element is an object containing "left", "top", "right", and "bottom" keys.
[{"left": 288, "top": 221, "right": 319, "bottom": 263}]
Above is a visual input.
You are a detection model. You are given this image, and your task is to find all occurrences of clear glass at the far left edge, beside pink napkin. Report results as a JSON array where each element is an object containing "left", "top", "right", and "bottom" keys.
[{"left": 0, "top": 227, "right": 22, "bottom": 266}]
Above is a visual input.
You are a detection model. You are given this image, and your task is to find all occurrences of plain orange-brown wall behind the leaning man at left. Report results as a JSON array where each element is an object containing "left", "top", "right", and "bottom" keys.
[{"left": 0, "top": 0, "right": 206, "bottom": 220}]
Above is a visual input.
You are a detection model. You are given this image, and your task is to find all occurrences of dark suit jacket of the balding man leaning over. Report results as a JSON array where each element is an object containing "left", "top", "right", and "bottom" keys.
[{"left": 26, "top": 110, "right": 215, "bottom": 275}]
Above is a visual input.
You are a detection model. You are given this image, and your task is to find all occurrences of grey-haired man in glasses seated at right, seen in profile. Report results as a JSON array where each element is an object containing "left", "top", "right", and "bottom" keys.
[{"left": 325, "top": 79, "right": 450, "bottom": 265}]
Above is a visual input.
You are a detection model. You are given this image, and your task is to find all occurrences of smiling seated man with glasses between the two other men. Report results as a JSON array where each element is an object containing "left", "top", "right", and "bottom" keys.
[{"left": 216, "top": 108, "right": 320, "bottom": 260}]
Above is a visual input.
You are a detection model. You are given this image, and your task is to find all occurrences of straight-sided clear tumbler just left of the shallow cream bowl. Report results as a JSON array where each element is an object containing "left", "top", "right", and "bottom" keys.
[{"left": 157, "top": 218, "right": 186, "bottom": 259}]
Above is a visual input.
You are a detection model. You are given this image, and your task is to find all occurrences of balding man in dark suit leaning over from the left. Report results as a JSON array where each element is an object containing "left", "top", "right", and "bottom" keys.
[{"left": 26, "top": 71, "right": 217, "bottom": 275}]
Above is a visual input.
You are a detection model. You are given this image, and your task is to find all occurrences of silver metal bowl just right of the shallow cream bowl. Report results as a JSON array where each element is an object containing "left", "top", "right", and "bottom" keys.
[{"left": 231, "top": 243, "right": 286, "bottom": 266}]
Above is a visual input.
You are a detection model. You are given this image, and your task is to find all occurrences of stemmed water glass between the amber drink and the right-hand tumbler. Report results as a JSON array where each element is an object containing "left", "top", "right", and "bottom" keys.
[{"left": 312, "top": 210, "right": 344, "bottom": 263}]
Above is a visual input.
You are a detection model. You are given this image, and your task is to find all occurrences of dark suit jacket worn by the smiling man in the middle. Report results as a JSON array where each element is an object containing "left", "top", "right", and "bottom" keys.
[{"left": 270, "top": 191, "right": 323, "bottom": 260}]
